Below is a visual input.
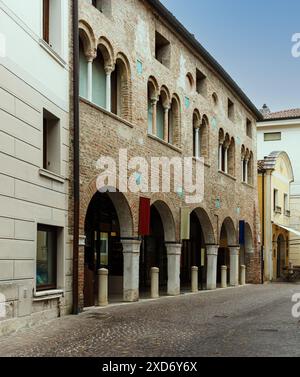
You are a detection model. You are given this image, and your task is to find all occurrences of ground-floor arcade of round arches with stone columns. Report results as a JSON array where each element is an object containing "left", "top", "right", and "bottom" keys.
[{"left": 83, "top": 192, "right": 253, "bottom": 307}]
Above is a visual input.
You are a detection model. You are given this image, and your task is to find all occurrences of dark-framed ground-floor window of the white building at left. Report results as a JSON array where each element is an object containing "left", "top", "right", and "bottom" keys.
[{"left": 36, "top": 225, "right": 58, "bottom": 291}]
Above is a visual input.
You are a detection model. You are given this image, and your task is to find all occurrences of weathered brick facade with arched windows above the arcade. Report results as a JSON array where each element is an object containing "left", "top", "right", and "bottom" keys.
[{"left": 70, "top": 0, "right": 260, "bottom": 308}]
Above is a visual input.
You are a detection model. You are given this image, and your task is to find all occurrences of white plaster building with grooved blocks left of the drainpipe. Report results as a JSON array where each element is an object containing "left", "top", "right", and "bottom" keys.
[{"left": 0, "top": 0, "right": 72, "bottom": 335}]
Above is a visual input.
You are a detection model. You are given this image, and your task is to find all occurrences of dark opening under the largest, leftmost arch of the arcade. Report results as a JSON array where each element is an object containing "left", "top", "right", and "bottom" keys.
[{"left": 84, "top": 192, "right": 132, "bottom": 307}]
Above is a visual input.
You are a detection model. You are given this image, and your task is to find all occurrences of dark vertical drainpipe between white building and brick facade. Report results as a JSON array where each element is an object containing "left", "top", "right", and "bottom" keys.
[{"left": 72, "top": 0, "right": 80, "bottom": 314}]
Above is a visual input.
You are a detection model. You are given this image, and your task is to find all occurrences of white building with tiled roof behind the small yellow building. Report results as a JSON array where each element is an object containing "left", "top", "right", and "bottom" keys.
[{"left": 257, "top": 106, "right": 300, "bottom": 265}]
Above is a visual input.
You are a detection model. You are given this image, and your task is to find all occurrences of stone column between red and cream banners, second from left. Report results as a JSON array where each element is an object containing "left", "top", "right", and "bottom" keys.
[{"left": 166, "top": 243, "right": 182, "bottom": 296}]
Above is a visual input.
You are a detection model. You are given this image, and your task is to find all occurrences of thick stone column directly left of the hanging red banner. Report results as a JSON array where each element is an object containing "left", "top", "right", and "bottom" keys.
[{"left": 122, "top": 240, "right": 141, "bottom": 302}]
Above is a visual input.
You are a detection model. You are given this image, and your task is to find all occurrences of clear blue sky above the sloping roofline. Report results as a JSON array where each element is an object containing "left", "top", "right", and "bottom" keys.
[{"left": 161, "top": 0, "right": 300, "bottom": 111}]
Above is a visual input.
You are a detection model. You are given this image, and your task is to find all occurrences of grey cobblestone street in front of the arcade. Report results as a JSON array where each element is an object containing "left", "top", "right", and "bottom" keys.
[{"left": 0, "top": 284, "right": 300, "bottom": 357}]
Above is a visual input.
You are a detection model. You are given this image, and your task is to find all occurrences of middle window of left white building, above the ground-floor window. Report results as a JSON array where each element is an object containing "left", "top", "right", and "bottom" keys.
[{"left": 43, "top": 109, "right": 61, "bottom": 175}]
